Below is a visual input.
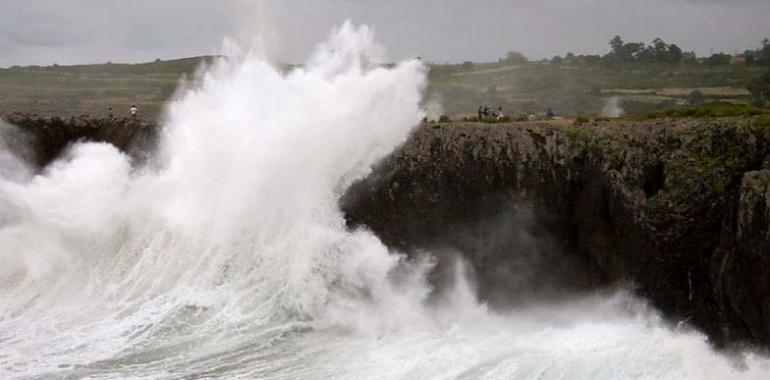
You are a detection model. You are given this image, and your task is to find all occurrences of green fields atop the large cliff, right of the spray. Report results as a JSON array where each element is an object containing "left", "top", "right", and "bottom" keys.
[{"left": 429, "top": 63, "right": 762, "bottom": 117}]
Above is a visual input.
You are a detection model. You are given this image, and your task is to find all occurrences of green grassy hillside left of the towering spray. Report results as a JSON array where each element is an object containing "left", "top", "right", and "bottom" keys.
[{"left": 0, "top": 57, "right": 211, "bottom": 118}]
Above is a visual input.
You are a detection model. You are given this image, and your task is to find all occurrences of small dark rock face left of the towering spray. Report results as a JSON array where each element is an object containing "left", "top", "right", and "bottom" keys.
[{"left": 3, "top": 114, "right": 159, "bottom": 168}]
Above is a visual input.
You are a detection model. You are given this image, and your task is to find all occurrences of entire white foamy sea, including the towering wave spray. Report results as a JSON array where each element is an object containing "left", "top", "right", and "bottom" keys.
[{"left": 0, "top": 24, "right": 770, "bottom": 379}]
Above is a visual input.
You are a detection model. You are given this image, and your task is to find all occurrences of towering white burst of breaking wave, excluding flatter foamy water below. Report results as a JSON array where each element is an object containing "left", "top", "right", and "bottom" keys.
[{"left": 0, "top": 24, "right": 432, "bottom": 378}]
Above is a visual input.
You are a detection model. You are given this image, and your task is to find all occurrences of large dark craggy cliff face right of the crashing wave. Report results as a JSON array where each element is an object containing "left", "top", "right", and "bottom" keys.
[{"left": 342, "top": 118, "right": 770, "bottom": 345}]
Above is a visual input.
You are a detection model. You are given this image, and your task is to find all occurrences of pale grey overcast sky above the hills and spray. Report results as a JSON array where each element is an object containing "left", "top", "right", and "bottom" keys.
[{"left": 0, "top": 0, "right": 770, "bottom": 67}]
